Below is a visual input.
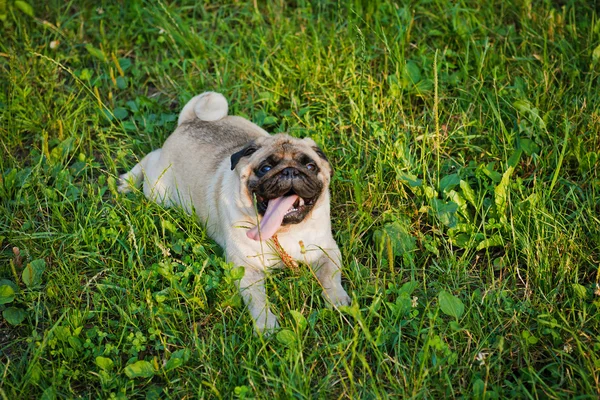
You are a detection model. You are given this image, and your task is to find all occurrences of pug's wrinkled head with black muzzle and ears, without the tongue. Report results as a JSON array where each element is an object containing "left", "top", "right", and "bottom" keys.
[{"left": 231, "top": 134, "right": 331, "bottom": 225}]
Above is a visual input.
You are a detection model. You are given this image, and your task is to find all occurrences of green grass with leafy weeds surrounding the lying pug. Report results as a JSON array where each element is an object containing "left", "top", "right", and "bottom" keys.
[{"left": 0, "top": 0, "right": 600, "bottom": 399}]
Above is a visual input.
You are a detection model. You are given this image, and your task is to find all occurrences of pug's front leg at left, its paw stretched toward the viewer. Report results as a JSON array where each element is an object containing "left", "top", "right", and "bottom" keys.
[{"left": 238, "top": 266, "right": 279, "bottom": 335}]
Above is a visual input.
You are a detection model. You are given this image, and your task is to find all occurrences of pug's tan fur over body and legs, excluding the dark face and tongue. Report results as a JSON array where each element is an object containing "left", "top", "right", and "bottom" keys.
[{"left": 119, "top": 92, "right": 350, "bottom": 333}]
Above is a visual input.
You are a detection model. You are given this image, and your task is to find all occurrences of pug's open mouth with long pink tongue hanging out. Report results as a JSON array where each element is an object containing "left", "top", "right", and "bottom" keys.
[{"left": 246, "top": 189, "right": 317, "bottom": 240}]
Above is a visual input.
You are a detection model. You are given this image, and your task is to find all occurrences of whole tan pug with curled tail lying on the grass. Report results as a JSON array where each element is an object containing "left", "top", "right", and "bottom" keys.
[{"left": 118, "top": 92, "right": 350, "bottom": 334}]
